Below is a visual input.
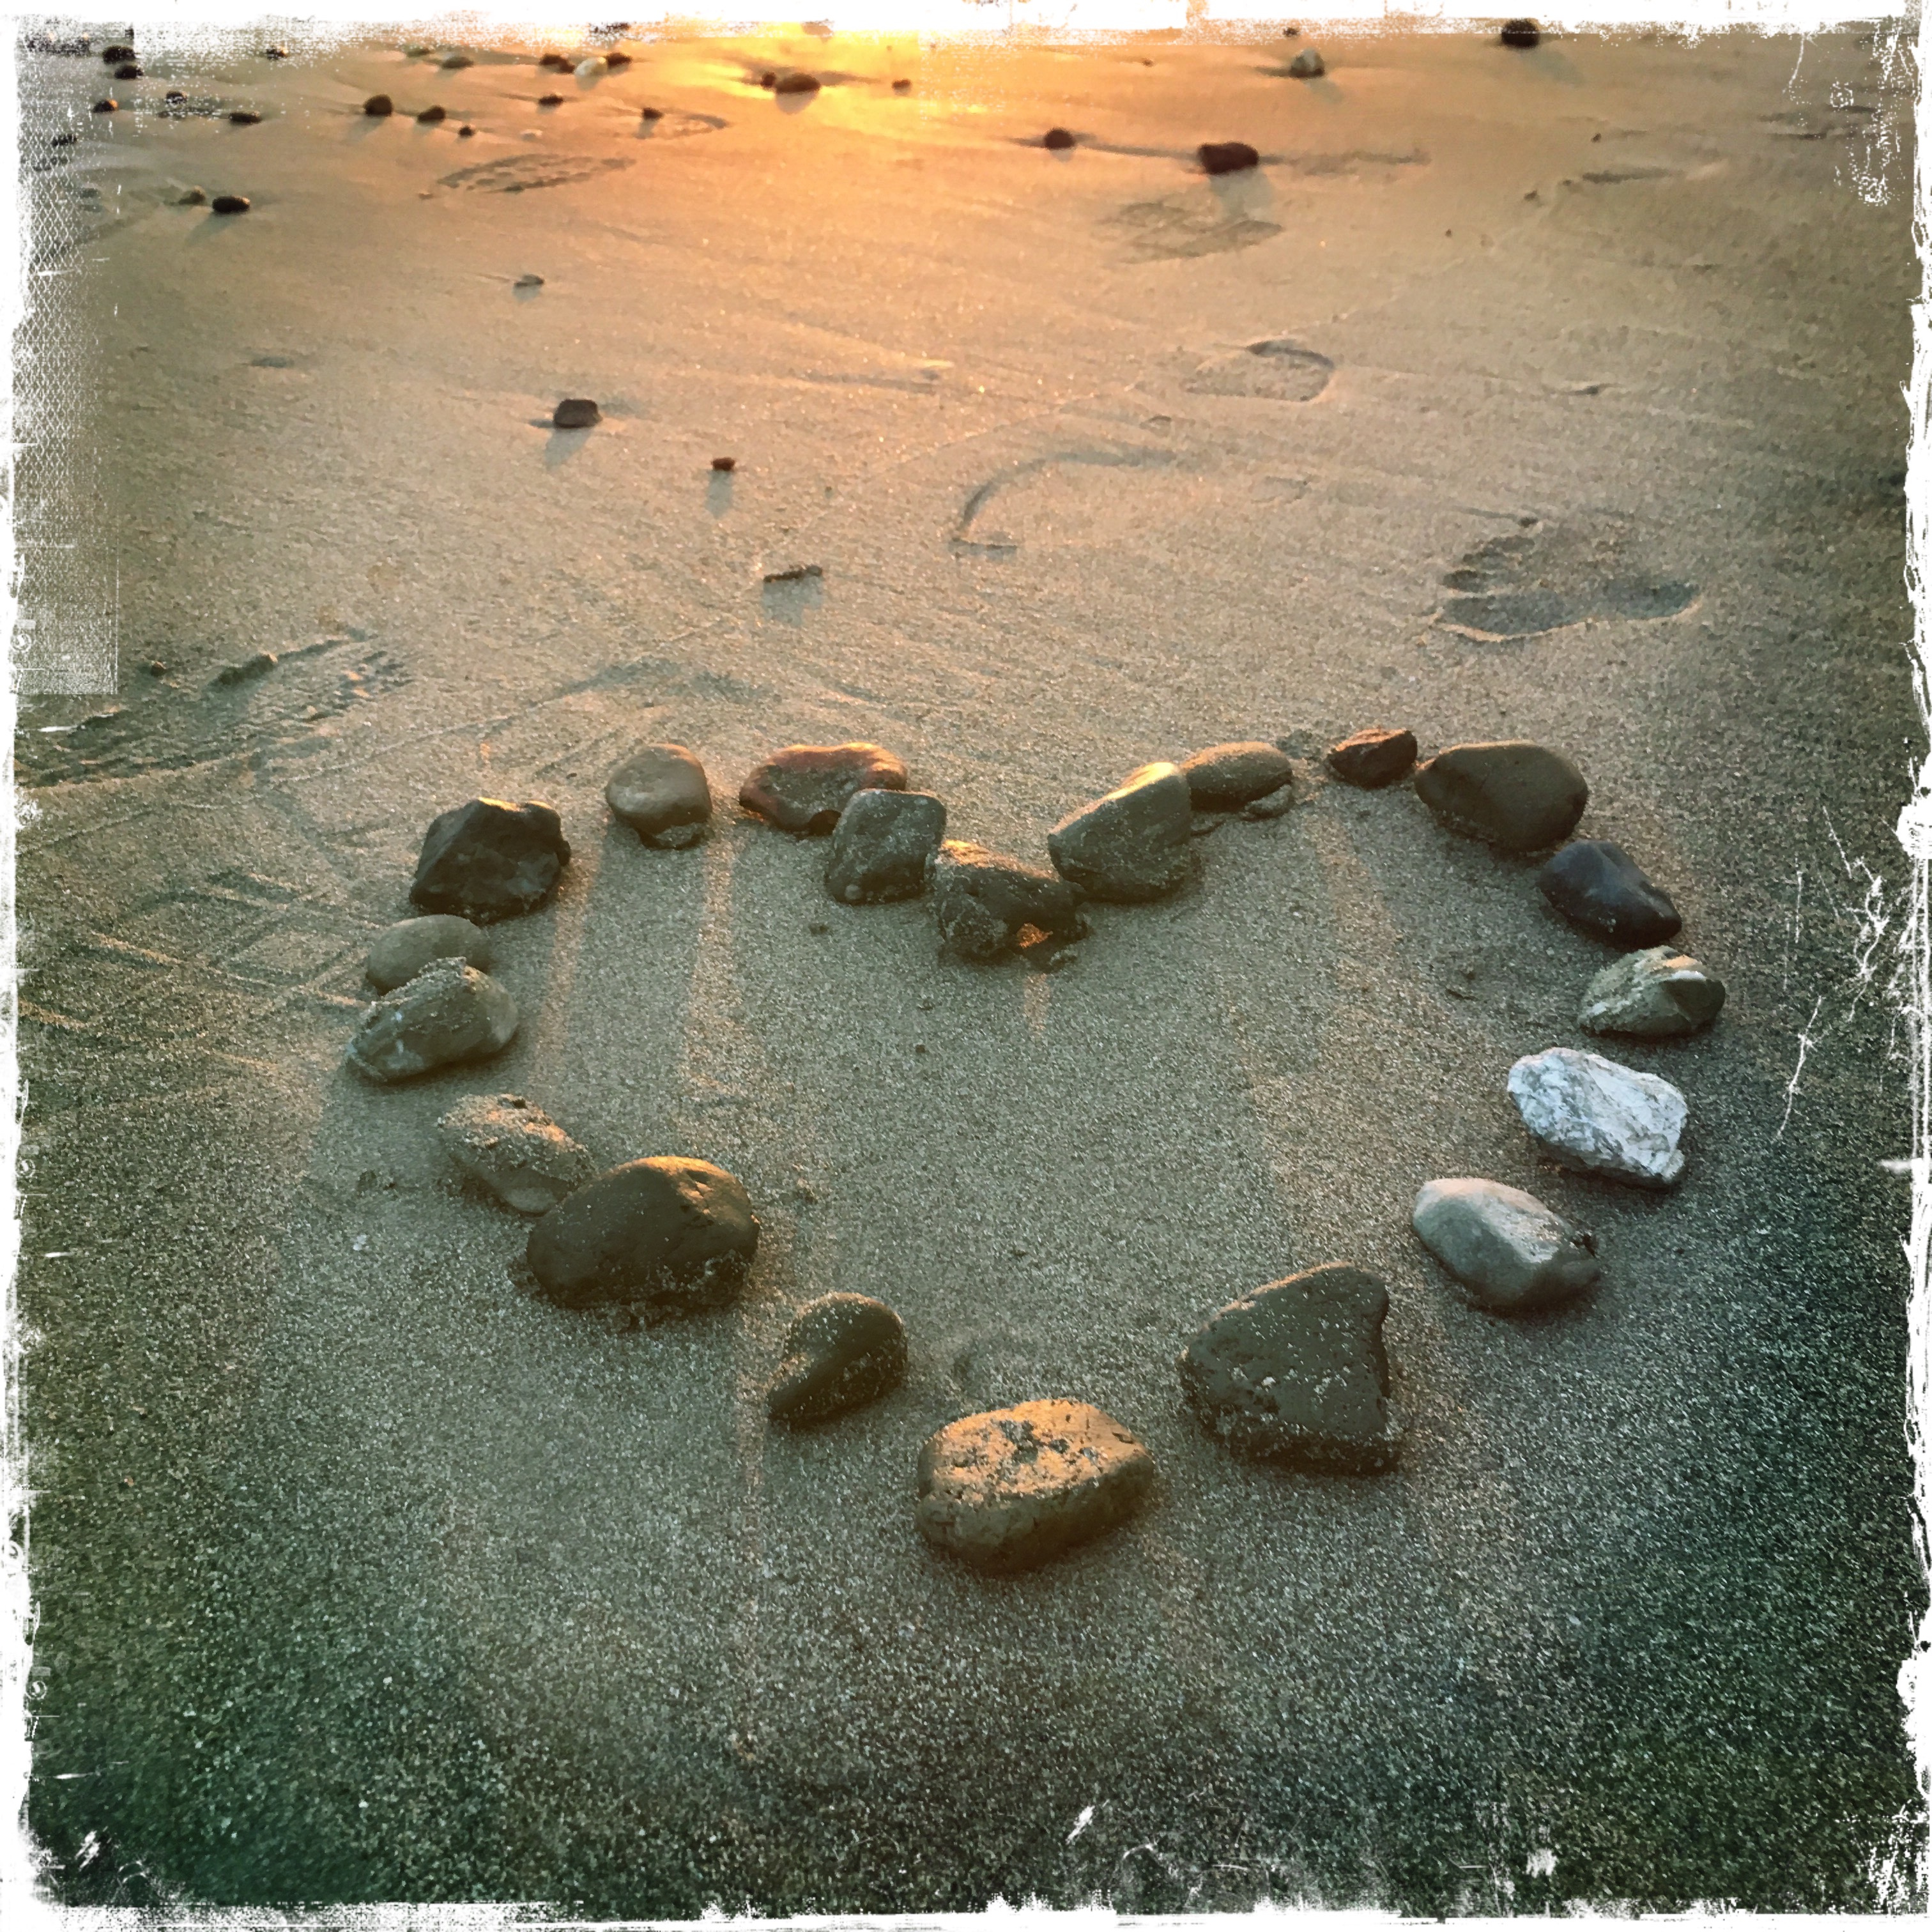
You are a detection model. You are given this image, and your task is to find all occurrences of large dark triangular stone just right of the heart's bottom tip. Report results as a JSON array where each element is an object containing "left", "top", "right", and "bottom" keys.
[{"left": 1179, "top": 1262, "right": 1400, "bottom": 1470}]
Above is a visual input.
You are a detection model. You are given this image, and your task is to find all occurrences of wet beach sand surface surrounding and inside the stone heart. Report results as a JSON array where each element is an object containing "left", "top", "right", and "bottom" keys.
[{"left": 17, "top": 15, "right": 1922, "bottom": 1915}]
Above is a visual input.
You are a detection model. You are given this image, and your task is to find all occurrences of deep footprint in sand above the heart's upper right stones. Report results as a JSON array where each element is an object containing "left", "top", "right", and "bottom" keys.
[{"left": 1436, "top": 518, "right": 1698, "bottom": 641}]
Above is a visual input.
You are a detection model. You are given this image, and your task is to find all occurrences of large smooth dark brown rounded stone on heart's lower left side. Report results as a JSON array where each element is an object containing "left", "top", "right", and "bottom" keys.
[{"left": 526, "top": 1153, "right": 757, "bottom": 1308}]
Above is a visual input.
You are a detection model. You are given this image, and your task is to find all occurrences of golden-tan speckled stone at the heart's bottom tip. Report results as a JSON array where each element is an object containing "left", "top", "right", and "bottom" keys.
[{"left": 917, "top": 1400, "right": 1153, "bottom": 1573}]
